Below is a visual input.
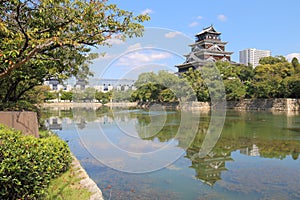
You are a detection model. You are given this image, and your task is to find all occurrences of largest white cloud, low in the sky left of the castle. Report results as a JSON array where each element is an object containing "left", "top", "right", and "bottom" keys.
[{"left": 117, "top": 51, "right": 172, "bottom": 67}]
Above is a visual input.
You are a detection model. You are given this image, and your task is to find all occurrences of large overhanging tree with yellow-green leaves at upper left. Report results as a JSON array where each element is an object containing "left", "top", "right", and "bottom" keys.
[{"left": 0, "top": 0, "right": 149, "bottom": 106}]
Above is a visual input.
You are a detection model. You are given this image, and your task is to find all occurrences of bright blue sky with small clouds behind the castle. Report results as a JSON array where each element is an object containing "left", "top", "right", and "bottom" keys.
[{"left": 92, "top": 0, "right": 300, "bottom": 78}]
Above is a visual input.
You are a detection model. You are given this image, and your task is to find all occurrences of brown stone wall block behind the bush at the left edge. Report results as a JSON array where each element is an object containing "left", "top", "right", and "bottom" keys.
[{"left": 0, "top": 112, "right": 39, "bottom": 137}]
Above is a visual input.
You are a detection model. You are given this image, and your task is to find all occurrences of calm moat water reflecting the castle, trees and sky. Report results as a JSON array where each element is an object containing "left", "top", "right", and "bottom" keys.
[{"left": 43, "top": 107, "right": 300, "bottom": 200}]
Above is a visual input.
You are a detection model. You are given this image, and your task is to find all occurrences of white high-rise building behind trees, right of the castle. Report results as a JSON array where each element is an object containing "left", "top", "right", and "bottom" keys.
[{"left": 240, "top": 48, "right": 271, "bottom": 68}]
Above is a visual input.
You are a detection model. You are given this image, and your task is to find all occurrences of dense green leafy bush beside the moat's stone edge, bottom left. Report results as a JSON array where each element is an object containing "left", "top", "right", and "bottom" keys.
[{"left": 0, "top": 125, "right": 71, "bottom": 199}]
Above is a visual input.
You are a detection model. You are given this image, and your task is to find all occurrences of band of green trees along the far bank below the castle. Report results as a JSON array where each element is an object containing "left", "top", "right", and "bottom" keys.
[{"left": 133, "top": 56, "right": 300, "bottom": 102}]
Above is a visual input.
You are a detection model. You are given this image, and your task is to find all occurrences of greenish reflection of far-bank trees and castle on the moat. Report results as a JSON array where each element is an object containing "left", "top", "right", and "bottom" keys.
[{"left": 43, "top": 106, "right": 300, "bottom": 186}]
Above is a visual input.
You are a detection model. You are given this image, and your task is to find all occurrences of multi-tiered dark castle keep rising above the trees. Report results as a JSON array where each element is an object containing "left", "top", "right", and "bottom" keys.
[{"left": 176, "top": 25, "right": 233, "bottom": 73}]
